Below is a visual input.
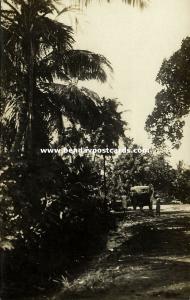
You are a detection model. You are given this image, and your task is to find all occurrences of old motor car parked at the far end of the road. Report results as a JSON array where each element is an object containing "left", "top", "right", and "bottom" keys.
[{"left": 130, "top": 185, "right": 154, "bottom": 210}]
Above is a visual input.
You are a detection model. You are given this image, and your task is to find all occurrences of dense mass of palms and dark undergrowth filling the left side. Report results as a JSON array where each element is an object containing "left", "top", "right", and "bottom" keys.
[{"left": 0, "top": 0, "right": 124, "bottom": 294}]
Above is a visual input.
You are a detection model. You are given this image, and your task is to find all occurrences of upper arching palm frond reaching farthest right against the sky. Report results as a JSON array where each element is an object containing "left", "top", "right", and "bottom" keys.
[{"left": 38, "top": 50, "right": 113, "bottom": 82}]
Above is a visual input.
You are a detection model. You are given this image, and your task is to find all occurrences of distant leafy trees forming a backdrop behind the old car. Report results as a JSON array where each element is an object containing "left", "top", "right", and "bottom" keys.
[{"left": 108, "top": 140, "right": 190, "bottom": 203}]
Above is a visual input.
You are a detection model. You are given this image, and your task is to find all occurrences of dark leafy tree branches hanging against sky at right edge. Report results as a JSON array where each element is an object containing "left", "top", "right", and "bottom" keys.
[{"left": 146, "top": 37, "right": 190, "bottom": 148}]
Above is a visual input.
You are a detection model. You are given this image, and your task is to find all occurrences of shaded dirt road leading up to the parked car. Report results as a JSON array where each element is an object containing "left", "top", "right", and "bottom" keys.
[{"left": 55, "top": 205, "right": 190, "bottom": 300}]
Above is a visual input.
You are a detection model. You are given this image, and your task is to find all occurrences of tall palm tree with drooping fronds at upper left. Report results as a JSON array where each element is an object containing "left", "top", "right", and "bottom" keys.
[{"left": 1, "top": 0, "right": 112, "bottom": 158}]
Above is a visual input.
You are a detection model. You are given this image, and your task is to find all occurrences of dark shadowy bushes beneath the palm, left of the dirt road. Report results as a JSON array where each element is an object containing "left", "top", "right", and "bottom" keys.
[{"left": 1, "top": 157, "right": 111, "bottom": 296}]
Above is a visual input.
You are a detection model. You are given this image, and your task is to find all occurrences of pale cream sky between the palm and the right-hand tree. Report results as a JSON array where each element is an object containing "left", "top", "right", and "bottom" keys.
[{"left": 59, "top": 0, "right": 190, "bottom": 165}]
